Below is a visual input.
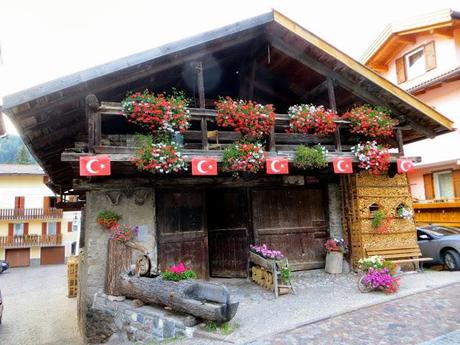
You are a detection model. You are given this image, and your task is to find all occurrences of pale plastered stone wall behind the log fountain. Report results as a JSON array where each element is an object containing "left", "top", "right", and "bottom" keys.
[{"left": 78, "top": 188, "right": 157, "bottom": 342}]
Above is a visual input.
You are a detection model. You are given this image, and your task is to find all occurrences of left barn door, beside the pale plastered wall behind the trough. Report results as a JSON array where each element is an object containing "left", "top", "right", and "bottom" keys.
[{"left": 156, "top": 190, "right": 208, "bottom": 278}]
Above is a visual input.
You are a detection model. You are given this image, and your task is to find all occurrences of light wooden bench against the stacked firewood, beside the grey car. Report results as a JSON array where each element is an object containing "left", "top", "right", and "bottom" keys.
[{"left": 366, "top": 245, "right": 433, "bottom": 271}]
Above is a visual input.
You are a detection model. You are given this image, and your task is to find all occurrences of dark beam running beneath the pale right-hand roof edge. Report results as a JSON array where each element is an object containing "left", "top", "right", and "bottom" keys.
[{"left": 273, "top": 37, "right": 436, "bottom": 138}]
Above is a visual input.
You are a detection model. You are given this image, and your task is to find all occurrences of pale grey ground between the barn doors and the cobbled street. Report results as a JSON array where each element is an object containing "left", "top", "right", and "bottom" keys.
[{"left": 177, "top": 270, "right": 460, "bottom": 345}]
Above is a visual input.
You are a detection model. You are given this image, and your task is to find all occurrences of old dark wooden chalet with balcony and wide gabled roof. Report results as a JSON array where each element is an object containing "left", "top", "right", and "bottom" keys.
[{"left": 0, "top": 11, "right": 452, "bottom": 338}]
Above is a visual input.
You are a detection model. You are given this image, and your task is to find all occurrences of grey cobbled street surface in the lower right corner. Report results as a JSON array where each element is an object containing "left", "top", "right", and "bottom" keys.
[{"left": 250, "top": 283, "right": 460, "bottom": 345}]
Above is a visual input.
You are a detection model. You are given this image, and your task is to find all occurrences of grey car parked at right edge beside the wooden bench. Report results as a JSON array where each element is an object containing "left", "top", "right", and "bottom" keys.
[{"left": 417, "top": 227, "right": 460, "bottom": 271}]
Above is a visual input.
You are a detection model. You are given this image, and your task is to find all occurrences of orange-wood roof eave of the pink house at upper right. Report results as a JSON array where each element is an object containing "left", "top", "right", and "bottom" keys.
[{"left": 361, "top": 9, "right": 460, "bottom": 72}]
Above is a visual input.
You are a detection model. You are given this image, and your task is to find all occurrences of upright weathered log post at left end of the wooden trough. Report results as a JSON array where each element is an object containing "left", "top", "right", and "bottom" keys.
[{"left": 105, "top": 240, "right": 132, "bottom": 296}]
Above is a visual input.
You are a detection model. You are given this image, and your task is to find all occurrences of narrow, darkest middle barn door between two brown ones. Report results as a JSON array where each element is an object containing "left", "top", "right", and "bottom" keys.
[{"left": 207, "top": 188, "right": 249, "bottom": 277}]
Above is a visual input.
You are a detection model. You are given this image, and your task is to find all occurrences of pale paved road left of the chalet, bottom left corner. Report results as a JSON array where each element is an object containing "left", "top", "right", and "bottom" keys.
[{"left": 0, "top": 265, "right": 81, "bottom": 345}]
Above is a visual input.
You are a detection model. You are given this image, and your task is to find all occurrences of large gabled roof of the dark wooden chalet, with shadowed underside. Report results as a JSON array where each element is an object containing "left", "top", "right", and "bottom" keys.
[{"left": 3, "top": 11, "right": 453, "bottom": 188}]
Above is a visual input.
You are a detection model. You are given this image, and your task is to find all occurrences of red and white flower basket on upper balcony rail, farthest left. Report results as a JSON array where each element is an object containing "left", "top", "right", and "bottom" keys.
[{"left": 121, "top": 90, "right": 190, "bottom": 133}]
